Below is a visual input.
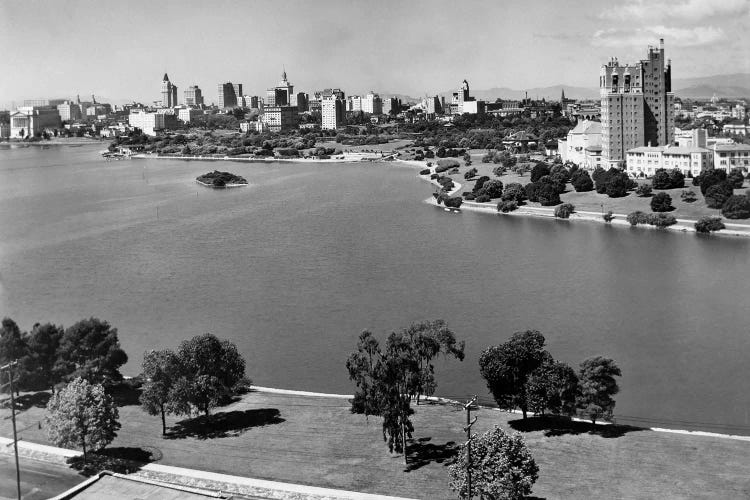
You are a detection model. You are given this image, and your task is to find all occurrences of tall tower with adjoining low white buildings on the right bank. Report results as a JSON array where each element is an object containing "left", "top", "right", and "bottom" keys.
[{"left": 557, "top": 40, "right": 750, "bottom": 177}]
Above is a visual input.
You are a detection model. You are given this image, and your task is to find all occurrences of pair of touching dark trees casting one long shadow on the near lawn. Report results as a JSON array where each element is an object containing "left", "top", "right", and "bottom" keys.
[{"left": 140, "top": 333, "right": 252, "bottom": 435}]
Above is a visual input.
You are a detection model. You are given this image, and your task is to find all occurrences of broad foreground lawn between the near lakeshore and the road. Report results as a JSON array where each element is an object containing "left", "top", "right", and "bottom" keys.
[{"left": 0, "top": 392, "right": 750, "bottom": 499}]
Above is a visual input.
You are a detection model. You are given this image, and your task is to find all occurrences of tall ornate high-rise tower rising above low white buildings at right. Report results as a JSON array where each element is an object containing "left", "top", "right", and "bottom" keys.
[{"left": 599, "top": 39, "right": 674, "bottom": 167}]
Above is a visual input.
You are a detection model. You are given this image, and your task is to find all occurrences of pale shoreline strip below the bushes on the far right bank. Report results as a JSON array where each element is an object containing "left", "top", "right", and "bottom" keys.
[{"left": 408, "top": 160, "right": 750, "bottom": 238}]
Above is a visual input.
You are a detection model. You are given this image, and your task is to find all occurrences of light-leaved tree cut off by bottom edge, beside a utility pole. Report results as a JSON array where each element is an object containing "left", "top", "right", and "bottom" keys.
[{"left": 448, "top": 426, "right": 539, "bottom": 500}]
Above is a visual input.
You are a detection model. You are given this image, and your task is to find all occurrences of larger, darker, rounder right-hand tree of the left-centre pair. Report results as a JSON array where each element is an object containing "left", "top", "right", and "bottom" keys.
[{"left": 175, "top": 333, "right": 245, "bottom": 416}]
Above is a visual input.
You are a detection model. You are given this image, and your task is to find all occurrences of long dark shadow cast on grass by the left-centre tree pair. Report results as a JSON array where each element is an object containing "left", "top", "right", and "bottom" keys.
[{"left": 165, "top": 408, "right": 285, "bottom": 439}]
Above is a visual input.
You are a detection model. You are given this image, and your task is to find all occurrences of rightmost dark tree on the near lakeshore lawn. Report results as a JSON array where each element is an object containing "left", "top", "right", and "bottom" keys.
[{"left": 576, "top": 356, "right": 622, "bottom": 424}]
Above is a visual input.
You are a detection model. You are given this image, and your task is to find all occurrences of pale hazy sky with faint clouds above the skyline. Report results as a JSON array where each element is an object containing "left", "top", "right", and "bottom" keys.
[{"left": 0, "top": 0, "right": 750, "bottom": 106}]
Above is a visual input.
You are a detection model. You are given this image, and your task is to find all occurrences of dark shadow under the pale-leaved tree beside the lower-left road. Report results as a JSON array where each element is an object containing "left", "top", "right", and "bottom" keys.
[{"left": 67, "top": 446, "right": 162, "bottom": 476}]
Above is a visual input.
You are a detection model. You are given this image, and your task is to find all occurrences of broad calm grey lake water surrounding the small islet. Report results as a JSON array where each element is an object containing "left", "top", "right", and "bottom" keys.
[{"left": 0, "top": 146, "right": 750, "bottom": 434}]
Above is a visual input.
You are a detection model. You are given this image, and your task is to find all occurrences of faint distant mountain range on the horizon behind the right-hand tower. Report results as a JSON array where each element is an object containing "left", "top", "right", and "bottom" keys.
[{"left": 390, "top": 73, "right": 750, "bottom": 102}]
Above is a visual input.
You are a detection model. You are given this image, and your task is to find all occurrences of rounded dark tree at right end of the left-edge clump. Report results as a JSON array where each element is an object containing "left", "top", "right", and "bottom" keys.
[{"left": 55, "top": 318, "right": 128, "bottom": 384}]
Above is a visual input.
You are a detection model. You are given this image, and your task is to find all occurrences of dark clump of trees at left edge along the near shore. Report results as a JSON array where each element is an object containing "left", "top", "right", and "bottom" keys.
[{"left": 0, "top": 318, "right": 128, "bottom": 393}]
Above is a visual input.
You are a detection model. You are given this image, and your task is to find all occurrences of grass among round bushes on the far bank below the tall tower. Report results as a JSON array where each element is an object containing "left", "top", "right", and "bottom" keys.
[{"left": 451, "top": 160, "right": 750, "bottom": 224}]
